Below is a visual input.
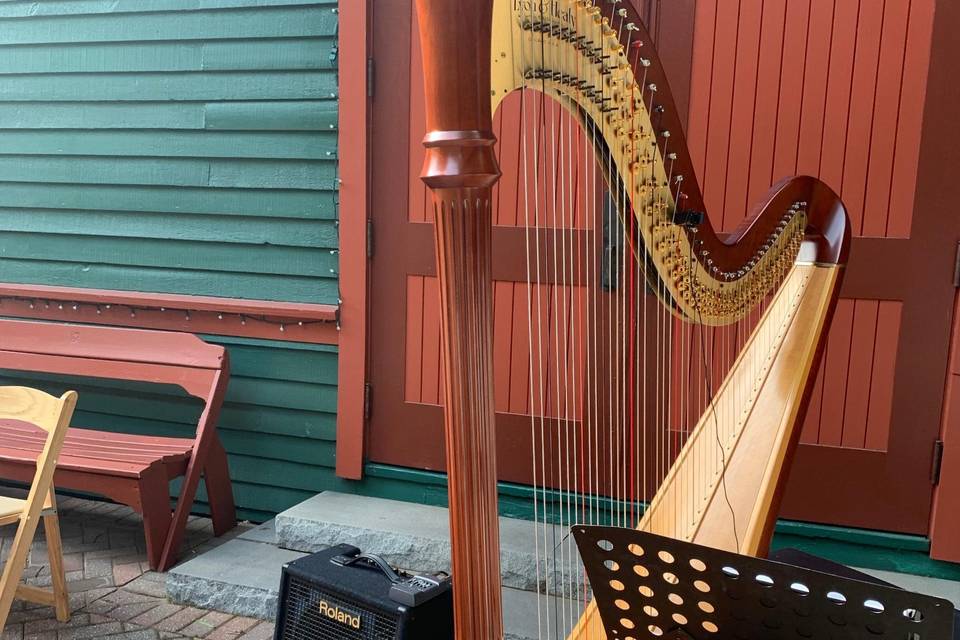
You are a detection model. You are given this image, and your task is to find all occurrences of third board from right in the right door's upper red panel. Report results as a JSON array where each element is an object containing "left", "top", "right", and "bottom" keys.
[{"left": 841, "top": 0, "right": 887, "bottom": 235}]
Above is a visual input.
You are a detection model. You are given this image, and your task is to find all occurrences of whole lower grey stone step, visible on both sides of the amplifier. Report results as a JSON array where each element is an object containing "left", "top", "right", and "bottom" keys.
[{"left": 167, "top": 522, "right": 580, "bottom": 640}]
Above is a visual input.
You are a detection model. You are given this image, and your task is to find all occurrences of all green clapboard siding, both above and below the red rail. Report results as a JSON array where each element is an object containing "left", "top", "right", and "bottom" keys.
[{"left": 0, "top": 0, "right": 349, "bottom": 520}]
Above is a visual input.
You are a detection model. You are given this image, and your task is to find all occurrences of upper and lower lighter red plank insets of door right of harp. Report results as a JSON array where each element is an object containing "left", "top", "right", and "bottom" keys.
[{"left": 687, "top": 0, "right": 934, "bottom": 450}]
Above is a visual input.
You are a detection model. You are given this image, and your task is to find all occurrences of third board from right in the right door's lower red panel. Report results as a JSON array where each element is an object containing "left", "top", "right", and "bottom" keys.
[{"left": 819, "top": 300, "right": 853, "bottom": 446}]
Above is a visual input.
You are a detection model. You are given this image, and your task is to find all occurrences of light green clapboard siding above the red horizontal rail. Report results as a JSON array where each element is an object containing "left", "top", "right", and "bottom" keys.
[{"left": 0, "top": 0, "right": 338, "bottom": 304}]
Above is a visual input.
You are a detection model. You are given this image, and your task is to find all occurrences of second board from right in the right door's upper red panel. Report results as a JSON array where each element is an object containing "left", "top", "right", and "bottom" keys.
[{"left": 860, "top": 0, "right": 910, "bottom": 237}]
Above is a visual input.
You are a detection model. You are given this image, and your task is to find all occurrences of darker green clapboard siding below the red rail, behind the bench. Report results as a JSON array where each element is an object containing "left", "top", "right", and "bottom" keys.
[{"left": 0, "top": 336, "right": 343, "bottom": 520}]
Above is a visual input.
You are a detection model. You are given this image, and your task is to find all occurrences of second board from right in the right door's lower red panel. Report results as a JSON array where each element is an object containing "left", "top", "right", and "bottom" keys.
[{"left": 841, "top": 300, "right": 879, "bottom": 449}]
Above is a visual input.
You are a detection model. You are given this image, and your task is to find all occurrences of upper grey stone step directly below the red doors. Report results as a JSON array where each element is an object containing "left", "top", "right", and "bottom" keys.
[{"left": 276, "top": 491, "right": 579, "bottom": 592}]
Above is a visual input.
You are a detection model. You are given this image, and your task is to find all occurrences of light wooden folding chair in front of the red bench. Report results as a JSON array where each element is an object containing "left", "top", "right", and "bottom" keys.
[{"left": 0, "top": 387, "right": 77, "bottom": 632}]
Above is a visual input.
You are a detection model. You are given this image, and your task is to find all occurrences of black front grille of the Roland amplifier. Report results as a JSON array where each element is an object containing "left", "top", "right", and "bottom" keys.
[{"left": 278, "top": 576, "right": 397, "bottom": 640}]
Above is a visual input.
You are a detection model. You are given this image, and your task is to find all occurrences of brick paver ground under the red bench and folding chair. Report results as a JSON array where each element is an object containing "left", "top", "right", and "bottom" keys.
[{"left": 0, "top": 489, "right": 273, "bottom": 640}]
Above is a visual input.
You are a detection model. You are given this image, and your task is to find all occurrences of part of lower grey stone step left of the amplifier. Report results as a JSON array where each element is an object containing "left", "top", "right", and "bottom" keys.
[{"left": 166, "top": 538, "right": 304, "bottom": 620}]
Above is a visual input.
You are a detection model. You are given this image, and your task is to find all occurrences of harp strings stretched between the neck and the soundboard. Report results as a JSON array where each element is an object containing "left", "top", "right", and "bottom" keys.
[{"left": 510, "top": 0, "right": 788, "bottom": 638}]
